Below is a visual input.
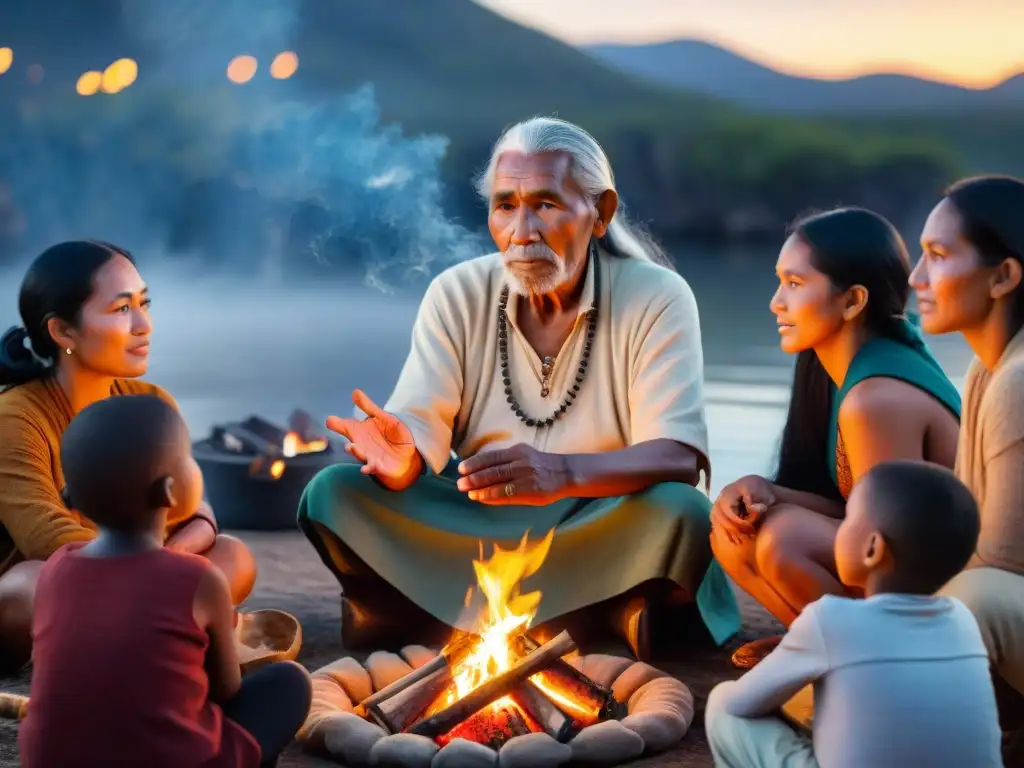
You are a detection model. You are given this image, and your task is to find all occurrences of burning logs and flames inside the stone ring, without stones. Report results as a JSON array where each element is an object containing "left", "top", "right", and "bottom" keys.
[{"left": 344, "top": 530, "right": 651, "bottom": 751}]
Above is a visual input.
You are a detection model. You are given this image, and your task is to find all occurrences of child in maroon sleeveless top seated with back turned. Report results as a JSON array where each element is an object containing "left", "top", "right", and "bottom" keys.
[{"left": 20, "top": 395, "right": 311, "bottom": 768}]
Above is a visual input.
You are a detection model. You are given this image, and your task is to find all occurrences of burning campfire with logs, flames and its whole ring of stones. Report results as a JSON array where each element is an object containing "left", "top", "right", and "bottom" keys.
[{"left": 297, "top": 531, "right": 693, "bottom": 768}]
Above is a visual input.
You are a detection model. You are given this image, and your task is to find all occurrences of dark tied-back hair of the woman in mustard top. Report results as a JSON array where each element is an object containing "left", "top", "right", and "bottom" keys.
[{"left": 0, "top": 240, "right": 135, "bottom": 389}]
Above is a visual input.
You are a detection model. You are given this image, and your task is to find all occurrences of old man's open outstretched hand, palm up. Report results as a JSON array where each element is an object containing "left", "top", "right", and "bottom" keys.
[{"left": 327, "top": 389, "right": 423, "bottom": 490}]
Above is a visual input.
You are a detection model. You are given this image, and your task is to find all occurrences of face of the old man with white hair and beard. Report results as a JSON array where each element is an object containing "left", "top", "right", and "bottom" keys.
[{"left": 487, "top": 152, "right": 604, "bottom": 296}]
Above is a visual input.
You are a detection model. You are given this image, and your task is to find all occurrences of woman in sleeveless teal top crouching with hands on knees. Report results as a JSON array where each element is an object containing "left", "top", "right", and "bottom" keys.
[{"left": 712, "top": 208, "right": 961, "bottom": 667}]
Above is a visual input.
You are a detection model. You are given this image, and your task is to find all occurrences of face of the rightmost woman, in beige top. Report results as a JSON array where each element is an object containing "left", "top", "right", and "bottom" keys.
[{"left": 910, "top": 200, "right": 996, "bottom": 334}]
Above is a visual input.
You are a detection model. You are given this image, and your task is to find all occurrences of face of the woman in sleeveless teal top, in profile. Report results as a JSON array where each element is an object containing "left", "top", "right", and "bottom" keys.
[{"left": 770, "top": 234, "right": 844, "bottom": 354}]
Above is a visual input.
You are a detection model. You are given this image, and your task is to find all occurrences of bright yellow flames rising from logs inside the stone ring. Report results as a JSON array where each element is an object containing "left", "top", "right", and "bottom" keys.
[{"left": 431, "top": 529, "right": 555, "bottom": 713}]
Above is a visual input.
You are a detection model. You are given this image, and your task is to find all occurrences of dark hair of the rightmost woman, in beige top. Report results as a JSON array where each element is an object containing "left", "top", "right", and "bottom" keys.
[{"left": 945, "top": 176, "right": 1024, "bottom": 335}]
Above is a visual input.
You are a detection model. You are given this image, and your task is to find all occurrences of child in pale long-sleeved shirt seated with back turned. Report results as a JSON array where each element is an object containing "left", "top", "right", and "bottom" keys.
[{"left": 705, "top": 462, "right": 1002, "bottom": 768}]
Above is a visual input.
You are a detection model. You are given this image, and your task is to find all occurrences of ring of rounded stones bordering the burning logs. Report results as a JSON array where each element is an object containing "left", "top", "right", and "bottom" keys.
[{"left": 297, "top": 645, "right": 693, "bottom": 768}]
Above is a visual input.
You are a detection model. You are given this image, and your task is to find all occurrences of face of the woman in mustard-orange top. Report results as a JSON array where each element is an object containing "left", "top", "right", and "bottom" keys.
[{"left": 51, "top": 255, "right": 153, "bottom": 379}]
